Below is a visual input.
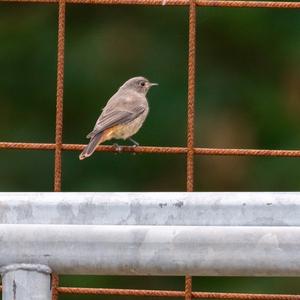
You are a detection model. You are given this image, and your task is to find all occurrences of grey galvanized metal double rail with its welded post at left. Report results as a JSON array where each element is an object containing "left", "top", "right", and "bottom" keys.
[{"left": 0, "top": 193, "right": 300, "bottom": 300}]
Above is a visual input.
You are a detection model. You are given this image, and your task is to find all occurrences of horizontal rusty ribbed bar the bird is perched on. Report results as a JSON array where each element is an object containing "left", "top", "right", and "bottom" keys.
[{"left": 0, "top": 142, "right": 300, "bottom": 157}]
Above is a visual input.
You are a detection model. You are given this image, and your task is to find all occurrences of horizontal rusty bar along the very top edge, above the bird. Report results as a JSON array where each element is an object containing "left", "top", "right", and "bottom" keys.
[{"left": 0, "top": 0, "right": 300, "bottom": 8}]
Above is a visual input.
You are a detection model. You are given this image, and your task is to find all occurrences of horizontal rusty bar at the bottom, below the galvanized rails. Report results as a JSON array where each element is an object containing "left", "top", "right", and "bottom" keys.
[{"left": 57, "top": 287, "right": 300, "bottom": 300}]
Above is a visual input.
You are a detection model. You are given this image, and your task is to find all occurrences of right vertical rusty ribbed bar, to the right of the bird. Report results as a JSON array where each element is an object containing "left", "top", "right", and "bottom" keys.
[{"left": 185, "top": 0, "right": 196, "bottom": 300}]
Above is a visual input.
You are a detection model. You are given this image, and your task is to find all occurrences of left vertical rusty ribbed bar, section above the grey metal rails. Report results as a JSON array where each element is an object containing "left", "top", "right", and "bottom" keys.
[{"left": 54, "top": 0, "right": 66, "bottom": 192}]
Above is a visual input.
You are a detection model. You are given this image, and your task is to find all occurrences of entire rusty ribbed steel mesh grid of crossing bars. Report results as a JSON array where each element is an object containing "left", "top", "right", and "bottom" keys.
[{"left": 0, "top": 0, "right": 300, "bottom": 300}]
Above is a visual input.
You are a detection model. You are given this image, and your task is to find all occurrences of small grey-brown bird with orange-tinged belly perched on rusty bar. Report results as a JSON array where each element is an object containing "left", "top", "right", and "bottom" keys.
[{"left": 79, "top": 76, "right": 158, "bottom": 160}]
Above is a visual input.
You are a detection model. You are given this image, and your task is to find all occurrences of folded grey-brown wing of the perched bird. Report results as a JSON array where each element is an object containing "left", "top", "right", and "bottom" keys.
[{"left": 87, "top": 105, "right": 146, "bottom": 138}]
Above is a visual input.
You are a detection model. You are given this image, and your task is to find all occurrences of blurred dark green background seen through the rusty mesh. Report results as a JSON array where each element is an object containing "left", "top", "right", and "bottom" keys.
[{"left": 0, "top": 3, "right": 300, "bottom": 299}]
